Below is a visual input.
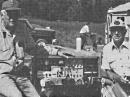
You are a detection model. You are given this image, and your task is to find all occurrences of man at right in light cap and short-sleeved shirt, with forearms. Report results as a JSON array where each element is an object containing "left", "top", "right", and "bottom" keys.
[{"left": 101, "top": 19, "right": 130, "bottom": 97}]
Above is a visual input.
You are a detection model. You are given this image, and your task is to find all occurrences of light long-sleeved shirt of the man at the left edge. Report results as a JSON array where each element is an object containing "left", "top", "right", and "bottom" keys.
[{"left": 0, "top": 31, "right": 24, "bottom": 74}]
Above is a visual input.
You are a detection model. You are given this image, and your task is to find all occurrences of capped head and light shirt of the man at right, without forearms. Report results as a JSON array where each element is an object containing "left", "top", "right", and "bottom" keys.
[{"left": 101, "top": 20, "right": 130, "bottom": 76}]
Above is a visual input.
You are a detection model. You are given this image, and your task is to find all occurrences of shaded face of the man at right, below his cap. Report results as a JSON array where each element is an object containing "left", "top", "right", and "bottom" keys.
[{"left": 110, "top": 27, "right": 126, "bottom": 42}]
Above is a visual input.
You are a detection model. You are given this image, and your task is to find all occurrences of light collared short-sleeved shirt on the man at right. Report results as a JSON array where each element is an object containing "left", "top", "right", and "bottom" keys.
[{"left": 101, "top": 41, "right": 130, "bottom": 76}]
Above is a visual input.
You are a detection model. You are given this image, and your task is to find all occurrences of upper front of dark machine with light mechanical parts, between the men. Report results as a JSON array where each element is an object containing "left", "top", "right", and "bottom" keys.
[{"left": 32, "top": 56, "right": 99, "bottom": 92}]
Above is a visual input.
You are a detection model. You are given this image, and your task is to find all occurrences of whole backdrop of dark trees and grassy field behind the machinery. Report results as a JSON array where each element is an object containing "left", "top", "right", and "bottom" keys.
[{"left": 0, "top": 0, "right": 130, "bottom": 48}]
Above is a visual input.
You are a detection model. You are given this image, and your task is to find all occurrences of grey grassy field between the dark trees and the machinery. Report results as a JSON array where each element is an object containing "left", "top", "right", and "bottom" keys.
[{"left": 29, "top": 18, "right": 105, "bottom": 48}]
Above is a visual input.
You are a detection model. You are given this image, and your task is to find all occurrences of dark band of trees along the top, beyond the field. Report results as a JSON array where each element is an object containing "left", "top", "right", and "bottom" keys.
[{"left": 0, "top": 0, "right": 130, "bottom": 22}]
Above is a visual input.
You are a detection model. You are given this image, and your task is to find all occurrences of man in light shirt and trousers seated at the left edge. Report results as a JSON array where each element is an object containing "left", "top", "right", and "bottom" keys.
[{"left": 0, "top": 10, "right": 39, "bottom": 97}]
